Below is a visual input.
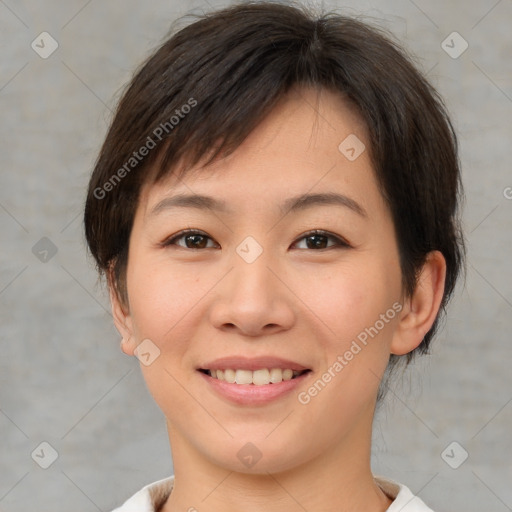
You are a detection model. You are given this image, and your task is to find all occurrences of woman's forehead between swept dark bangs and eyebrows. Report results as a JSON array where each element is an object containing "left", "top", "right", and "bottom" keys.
[{"left": 139, "top": 88, "right": 376, "bottom": 216}]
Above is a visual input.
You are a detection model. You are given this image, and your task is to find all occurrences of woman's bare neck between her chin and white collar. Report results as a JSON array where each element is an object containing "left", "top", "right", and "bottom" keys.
[{"left": 162, "top": 416, "right": 392, "bottom": 512}]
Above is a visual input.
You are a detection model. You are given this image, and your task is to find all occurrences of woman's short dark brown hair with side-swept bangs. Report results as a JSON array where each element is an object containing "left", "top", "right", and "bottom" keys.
[{"left": 84, "top": 2, "right": 464, "bottom": 363}]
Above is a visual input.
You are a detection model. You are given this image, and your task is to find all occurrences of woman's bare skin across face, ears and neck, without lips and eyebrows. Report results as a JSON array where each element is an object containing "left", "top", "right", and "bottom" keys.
[{"left": 111, "top": 89, "right": 445, "bottom": 512}]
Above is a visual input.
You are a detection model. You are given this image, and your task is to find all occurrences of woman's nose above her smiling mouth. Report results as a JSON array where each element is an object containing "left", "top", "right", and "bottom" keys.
[{"left": 210, "top": 247, "right": 296, "bottom": 337}]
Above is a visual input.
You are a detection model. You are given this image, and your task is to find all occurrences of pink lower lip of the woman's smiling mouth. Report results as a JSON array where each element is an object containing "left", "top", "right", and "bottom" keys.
[{"left": 199, "top": 372, "right": 311, "bottom": 405}]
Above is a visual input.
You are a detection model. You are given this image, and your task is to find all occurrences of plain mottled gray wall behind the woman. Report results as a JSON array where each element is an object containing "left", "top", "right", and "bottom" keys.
[{"left": 0, "top": 0, "right": 512, "bottom": 512}]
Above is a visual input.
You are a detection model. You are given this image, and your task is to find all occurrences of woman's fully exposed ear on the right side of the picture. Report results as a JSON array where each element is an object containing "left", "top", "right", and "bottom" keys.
[{"left": 390, "top": 251, "right": 446, "bottom": 355}]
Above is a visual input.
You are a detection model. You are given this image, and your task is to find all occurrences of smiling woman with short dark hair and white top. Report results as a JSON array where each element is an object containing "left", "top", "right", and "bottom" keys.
[{"left": 85, "top": 2, "right": 463, "bottom": 512}]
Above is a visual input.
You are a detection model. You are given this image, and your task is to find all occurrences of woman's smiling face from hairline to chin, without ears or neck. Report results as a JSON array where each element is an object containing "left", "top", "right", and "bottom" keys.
[{"left": 118, "top": 90, "right": 408, "bottom": 473}]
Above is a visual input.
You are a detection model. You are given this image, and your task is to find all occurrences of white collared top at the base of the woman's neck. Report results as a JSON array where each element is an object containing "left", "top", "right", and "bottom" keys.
[{"left": 112, "top": 476, "right": 434, "bottom": 512}]
